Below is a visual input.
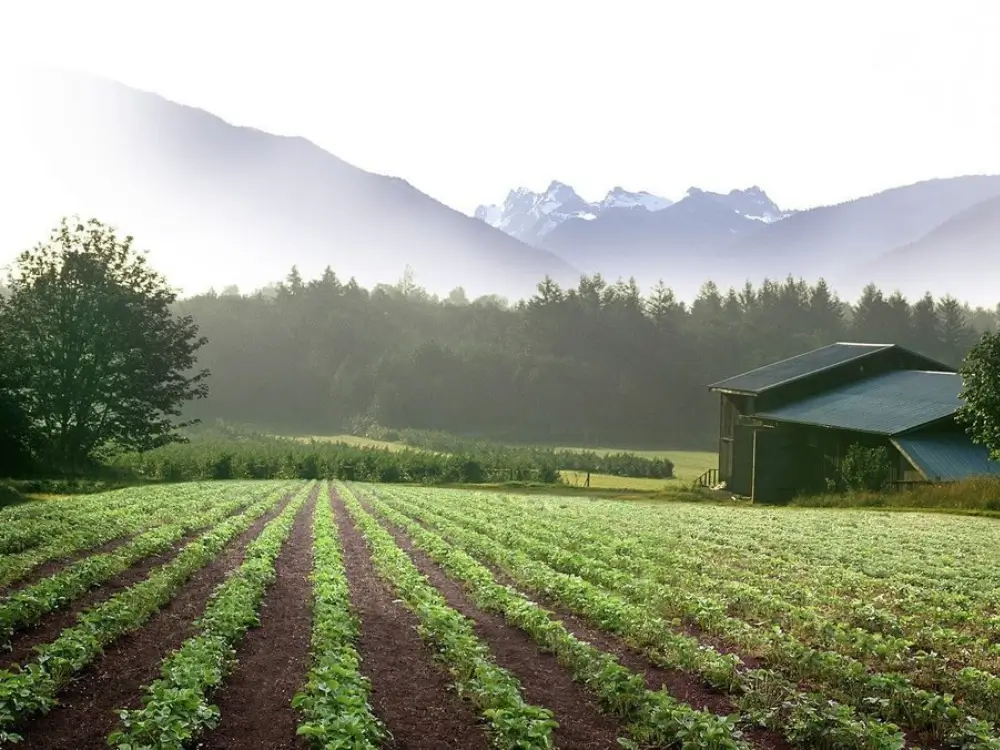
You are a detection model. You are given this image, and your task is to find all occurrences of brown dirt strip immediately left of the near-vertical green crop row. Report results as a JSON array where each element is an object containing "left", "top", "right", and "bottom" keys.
[{"left": 198, "top": 484, "right": 321, "bottom": 750}]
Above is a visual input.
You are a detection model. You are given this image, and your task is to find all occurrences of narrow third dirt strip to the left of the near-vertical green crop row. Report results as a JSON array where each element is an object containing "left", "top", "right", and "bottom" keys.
[{"left": 0, "top": 502, "right": 254, "bottom": 665}]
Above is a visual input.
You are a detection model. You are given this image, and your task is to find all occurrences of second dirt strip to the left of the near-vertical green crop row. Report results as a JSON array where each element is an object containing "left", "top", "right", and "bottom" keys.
[{"left": 7, "top": 493, "right": 293, "bottom": 750}]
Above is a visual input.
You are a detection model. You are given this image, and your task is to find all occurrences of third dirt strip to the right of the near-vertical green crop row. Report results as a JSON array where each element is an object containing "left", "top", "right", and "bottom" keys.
[{"left": 382, "top": 502, "right": 791, "bottom": 750}]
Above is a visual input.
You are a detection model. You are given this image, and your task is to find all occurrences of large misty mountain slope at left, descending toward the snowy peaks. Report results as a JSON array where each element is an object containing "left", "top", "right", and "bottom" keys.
[{"left": 0, "top": 70, "right": 580, "bottom": 299}]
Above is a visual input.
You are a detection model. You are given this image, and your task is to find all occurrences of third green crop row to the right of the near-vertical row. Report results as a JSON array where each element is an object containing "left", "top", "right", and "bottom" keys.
[{"left": 379, "top": 492, "right": 920, "bottom": 750}]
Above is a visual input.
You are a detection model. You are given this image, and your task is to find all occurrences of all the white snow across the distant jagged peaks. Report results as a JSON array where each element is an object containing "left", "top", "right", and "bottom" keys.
[{"left": 474, "top": 181, "right": 790, "bottom": 247}]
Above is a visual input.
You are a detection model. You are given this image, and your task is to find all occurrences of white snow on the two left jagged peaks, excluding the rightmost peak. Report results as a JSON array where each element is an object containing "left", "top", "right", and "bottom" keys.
[{"left": 473, "top": 180, "right": 671, "bottom": 245}]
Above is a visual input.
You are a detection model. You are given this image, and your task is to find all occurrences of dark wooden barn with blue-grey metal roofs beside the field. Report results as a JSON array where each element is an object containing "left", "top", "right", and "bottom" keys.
[{"left": 709, "top": 343, "right": 1000, "bottom": 503}]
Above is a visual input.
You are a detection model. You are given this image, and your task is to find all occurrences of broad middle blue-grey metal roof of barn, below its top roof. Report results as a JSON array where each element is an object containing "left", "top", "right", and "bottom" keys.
[{"left": 754, "top": 370, "right": 962, "bottom": 435}]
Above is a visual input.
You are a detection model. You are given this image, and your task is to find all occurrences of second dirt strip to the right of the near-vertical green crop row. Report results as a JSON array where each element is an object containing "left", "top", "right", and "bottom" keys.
[{"left": 358, "top": 500, "right": 626, "bottom": 750}]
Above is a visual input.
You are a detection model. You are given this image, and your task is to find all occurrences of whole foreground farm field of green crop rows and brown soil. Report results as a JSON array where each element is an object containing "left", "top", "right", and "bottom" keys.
[{"left": 0, "top": 480, "right": 1000, "bottom": 750}]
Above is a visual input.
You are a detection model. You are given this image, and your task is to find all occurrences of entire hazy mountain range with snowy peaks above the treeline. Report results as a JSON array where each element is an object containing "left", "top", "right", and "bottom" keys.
[{"left": 0, "top": 70, "right": 1000, "bottom": 306}]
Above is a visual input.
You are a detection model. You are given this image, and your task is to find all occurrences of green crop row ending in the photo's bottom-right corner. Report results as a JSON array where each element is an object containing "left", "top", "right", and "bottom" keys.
[{"left": 438, "top": 490, "right": 1000, "bottom": 748}]
